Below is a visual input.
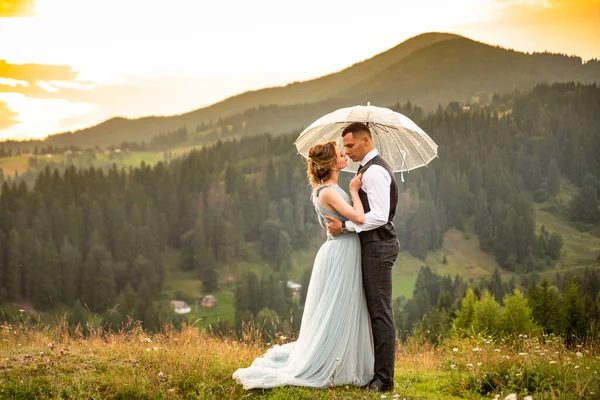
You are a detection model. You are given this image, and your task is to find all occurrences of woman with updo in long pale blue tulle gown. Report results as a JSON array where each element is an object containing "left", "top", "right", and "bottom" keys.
[{"left": 233, "top": 142, "right": 374, "bottom": 389}]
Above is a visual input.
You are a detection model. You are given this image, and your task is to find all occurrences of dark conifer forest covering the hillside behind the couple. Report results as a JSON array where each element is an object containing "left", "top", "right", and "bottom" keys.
[{"left": 0, "top": 83, "right": 600, "bottom": 340}]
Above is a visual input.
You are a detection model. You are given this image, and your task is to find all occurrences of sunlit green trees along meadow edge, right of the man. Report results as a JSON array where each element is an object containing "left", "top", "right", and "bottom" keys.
[{"left": 394, "top": 267, "right": 600, "bottom": 346}]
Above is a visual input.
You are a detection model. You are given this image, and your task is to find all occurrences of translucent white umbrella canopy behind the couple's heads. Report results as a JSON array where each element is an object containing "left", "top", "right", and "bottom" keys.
[{"left": 294, "top": 105, "right": 438, "bottom": 172}]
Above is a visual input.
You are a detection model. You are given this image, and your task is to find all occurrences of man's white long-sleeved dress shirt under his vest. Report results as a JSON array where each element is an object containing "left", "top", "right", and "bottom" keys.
[{"left": 346, "top": 149, "right": 392, "bottom": 232}]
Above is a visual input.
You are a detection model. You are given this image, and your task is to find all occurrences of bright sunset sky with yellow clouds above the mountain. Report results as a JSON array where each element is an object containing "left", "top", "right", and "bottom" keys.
[{"left": 0, "top": 0, "right": 600, "bottom": 140}]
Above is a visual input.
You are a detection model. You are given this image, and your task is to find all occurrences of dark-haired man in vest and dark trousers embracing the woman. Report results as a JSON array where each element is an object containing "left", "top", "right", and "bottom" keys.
[{"left": 327, "top": 122, "right": 400, "bottom": 392}]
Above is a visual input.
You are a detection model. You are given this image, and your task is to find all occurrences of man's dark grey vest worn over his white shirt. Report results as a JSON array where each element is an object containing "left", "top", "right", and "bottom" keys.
[{"left": 358, "top": 155, "right": 398, "bottom": 243}]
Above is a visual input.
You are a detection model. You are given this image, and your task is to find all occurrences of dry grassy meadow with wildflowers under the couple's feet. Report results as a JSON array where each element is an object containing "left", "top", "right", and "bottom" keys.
[{"left": 0, "top": 323, "right": 600, "bottom": 399}]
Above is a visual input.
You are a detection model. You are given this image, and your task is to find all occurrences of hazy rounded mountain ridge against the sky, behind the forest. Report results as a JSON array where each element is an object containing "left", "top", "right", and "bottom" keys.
[{"left": 39, "top": 33, "right": 600, "bottom": 147}]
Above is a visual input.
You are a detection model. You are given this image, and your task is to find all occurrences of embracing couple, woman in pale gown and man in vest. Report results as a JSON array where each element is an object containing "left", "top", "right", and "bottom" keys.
[{"left": 233, "top": 122, "right": 400, "bottom": 392}]
